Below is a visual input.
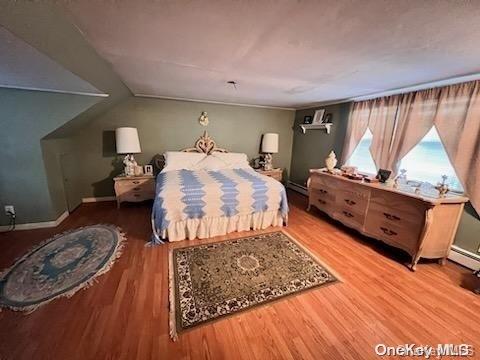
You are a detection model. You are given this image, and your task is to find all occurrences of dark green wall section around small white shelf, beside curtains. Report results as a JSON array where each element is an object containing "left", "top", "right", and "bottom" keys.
[{"left": 290, "top": 103, "right": 351, "bottom": 186}]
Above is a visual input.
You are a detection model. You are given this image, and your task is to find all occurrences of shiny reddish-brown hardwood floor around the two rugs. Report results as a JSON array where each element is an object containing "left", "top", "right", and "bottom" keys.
[{"left": 0, "top": 193, "right": 480, "bottom": 360}]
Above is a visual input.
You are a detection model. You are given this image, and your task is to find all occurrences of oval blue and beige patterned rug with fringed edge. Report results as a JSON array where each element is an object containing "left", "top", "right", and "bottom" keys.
[{"left": 0, "top": 225, "right": 125, "bottom": 312}]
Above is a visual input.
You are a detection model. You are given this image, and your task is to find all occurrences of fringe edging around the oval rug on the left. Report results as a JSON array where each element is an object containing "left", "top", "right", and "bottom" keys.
[{"left": 0, "top": 224, "right": 127, "bottom": 315}]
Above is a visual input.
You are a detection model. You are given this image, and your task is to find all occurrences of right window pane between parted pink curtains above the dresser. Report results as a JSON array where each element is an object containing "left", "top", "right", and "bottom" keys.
[{"left": 400, "top": 127, "right": 463, "bottom": 192}]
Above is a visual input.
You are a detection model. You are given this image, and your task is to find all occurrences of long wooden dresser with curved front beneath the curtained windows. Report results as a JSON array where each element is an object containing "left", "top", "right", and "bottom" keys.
[{"left": 307, "top": 169, "right": 468, "bottom": 271}]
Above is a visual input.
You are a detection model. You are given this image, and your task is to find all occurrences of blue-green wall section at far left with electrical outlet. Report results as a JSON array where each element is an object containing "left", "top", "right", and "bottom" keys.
[{"left": 0, "top": 88, "right": 99, "bottom": 225}]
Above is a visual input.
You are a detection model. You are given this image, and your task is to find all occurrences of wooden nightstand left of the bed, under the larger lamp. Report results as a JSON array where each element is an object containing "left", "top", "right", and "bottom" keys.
[{"left": 113, "top": 175, "right": 155, "bottom": 208}]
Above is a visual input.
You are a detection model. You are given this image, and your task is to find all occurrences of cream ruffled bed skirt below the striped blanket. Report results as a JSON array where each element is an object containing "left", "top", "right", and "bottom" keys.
[{"left": 152, "top": 210, "right": 287, "bottom": 243}]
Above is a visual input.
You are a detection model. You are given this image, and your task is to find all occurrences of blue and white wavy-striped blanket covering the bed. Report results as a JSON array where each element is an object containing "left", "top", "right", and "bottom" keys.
[{"left": 152, "top": 168, "right": 288, "bottom": 243}]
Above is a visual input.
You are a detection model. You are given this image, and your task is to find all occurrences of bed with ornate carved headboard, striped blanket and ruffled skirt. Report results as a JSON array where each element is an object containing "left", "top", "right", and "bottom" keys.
[{"left": 152, "top": 132, "right": 288, "bottom": 244}]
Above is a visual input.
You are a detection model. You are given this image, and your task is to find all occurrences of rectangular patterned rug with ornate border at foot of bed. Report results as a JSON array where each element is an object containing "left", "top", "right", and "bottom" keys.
[{"left": 169, "top": 232, "right": 338, "bottom": 340}]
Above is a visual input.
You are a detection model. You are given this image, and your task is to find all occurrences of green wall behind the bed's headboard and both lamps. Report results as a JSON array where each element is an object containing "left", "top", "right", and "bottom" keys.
[{"left": 69, "top": 97, "right": 294, "bottom": 197}]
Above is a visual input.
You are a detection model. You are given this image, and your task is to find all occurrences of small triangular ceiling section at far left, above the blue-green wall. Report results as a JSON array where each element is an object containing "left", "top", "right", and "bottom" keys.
[{"left": 0, "top": 26, "right": 105, "bottom": 96}]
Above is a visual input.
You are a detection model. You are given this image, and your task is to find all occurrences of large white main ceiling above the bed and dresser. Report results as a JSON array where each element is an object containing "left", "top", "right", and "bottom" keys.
[{"left": 59, "top": 0, "right": 480, "bottom": 107}]
